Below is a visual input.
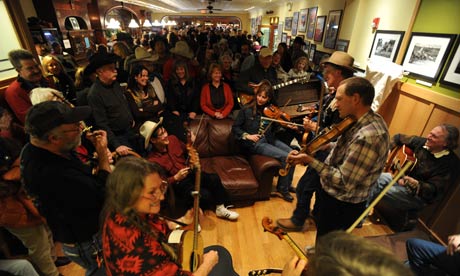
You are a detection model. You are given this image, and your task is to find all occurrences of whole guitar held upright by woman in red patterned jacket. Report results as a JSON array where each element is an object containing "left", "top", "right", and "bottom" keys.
[{"left": 168, "top": 145, "right": 203, "bottom": 272}]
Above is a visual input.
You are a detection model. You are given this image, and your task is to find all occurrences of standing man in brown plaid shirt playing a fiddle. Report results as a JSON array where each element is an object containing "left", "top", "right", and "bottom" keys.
[{"left": 287, "top": 77, "right": 390, "bottom": 239}]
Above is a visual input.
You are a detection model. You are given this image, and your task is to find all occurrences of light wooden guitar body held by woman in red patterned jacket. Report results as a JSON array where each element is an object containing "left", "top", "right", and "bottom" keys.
[{"left": 168, "top": 230, "right": 204, "bottom": 271}]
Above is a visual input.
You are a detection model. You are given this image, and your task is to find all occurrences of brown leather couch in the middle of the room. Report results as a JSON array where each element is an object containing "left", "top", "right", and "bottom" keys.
[{"left": 190, "top": 117, "right": 281, "bottom": 207}]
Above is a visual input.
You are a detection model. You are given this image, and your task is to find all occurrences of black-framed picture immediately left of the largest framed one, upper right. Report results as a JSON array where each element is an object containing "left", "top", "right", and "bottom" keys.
[{"left": 369, "top": 30, "right": 404, "bottom": 62}]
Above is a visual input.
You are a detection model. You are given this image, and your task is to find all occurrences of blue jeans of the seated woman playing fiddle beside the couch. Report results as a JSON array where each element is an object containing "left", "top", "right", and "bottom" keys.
[{"left": 254, "top": 137, "right": 295, "bottom": 193}]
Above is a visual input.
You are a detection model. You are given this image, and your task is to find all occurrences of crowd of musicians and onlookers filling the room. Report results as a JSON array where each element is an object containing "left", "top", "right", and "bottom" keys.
[{"left": 0, "top": 26, "right": 459, "bottom": 276}]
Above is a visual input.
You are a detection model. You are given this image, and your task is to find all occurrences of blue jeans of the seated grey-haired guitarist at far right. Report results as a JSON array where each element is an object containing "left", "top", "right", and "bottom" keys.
[{"left": 368, "top": 173, "right": 426, "bottom": 211}]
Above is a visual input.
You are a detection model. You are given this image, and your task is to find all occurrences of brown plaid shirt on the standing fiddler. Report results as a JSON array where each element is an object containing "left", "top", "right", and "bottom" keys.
[{"left": 310, "top": 111, "right": 390, "bottom": 203}]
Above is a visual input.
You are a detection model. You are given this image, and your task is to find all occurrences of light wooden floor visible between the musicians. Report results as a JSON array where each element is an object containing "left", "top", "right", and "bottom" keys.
[{"left": 59, "top": 166, "right": 392, "bottom": 276}]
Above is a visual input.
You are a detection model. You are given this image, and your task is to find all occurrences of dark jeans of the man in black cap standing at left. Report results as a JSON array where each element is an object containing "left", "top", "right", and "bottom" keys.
[{"left": 62, "top": 238, "right": 106, "bottom": 276}]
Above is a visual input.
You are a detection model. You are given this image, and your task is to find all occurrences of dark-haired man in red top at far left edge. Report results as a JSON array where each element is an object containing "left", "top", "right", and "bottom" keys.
[{"left": 5, "top": 49, "right": 54, "bottom": 126}]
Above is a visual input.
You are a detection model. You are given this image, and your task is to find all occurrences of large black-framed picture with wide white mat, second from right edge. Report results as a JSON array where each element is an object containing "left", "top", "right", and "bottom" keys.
[{"left": 402, "top": 33, "right": 455, "bottom": 81}]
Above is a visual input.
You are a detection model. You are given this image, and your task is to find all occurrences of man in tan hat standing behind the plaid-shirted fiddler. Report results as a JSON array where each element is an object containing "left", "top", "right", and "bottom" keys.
[{"left": 276, "top": 51, "right": 354, "bottom": 231}]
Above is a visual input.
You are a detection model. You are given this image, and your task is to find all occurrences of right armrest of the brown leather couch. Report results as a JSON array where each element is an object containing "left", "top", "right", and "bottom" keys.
[{"left": 248, "top": 154, "right": 281, "bottom": 200}]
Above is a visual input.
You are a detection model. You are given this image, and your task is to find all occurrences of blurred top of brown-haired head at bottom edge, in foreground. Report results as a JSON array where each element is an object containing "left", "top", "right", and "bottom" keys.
[{"left": 307, "top": 231, "right": 413, "bottom": 276}]
